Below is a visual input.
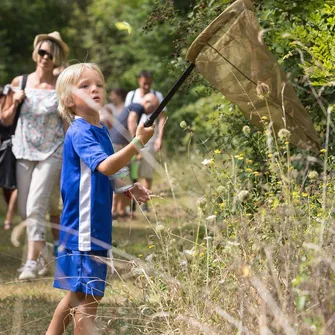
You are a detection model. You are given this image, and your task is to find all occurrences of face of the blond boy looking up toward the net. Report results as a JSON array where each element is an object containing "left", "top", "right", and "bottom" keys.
[{"left": 72, "top": 69, "right": 105, "bottom": 116}]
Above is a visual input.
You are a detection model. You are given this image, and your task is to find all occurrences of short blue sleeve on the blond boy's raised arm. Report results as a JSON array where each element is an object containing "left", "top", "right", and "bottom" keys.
[{"left": 72, "top": 129, "right": 108, "bottom": 171}]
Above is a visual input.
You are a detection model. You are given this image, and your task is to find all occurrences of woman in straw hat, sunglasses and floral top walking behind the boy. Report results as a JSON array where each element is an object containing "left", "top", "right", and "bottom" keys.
[{"left": 1, "top": 31, "right": 69, "bottom": 280}]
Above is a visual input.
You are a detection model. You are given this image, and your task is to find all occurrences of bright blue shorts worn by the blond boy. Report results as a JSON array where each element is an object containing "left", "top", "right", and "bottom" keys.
[{"left": 54, "top": 249, "right": 108, "bottom": 296}]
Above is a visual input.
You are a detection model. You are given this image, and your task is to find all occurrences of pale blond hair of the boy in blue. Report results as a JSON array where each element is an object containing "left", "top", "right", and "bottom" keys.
[{"left": 56, "top": 63, "right": 106, "bottom": 122}]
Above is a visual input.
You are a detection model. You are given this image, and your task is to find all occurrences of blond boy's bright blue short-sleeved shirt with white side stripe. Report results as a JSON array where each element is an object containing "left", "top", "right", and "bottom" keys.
[{"left": 60, "top": 118, "right": 114, "bottom": 251}]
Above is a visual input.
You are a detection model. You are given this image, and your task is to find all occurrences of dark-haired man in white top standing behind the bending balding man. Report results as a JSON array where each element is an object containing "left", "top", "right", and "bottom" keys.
[{"left": 125, "top": 70, "right": 166, "bottom": 211}]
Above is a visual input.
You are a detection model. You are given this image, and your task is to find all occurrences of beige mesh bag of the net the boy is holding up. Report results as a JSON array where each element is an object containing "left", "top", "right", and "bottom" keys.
[{"left": 186, "top": 0, "right": 320, "bottom": 151}]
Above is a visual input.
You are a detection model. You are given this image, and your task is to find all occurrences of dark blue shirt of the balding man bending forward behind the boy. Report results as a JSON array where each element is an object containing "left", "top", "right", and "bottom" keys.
[{"left": 110, "top": 103, "right": 144, "bottom": 144}]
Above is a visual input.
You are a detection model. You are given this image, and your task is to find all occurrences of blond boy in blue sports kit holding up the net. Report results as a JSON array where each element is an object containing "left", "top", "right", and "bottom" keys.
[{"left": 47, "top": 63, "right": 154, "bottom": 335}]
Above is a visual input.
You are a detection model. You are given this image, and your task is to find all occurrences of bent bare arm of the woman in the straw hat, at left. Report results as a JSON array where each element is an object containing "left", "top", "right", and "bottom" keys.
[{"left": 0, "top": 76, "right": 25, "bottom": 126}]
